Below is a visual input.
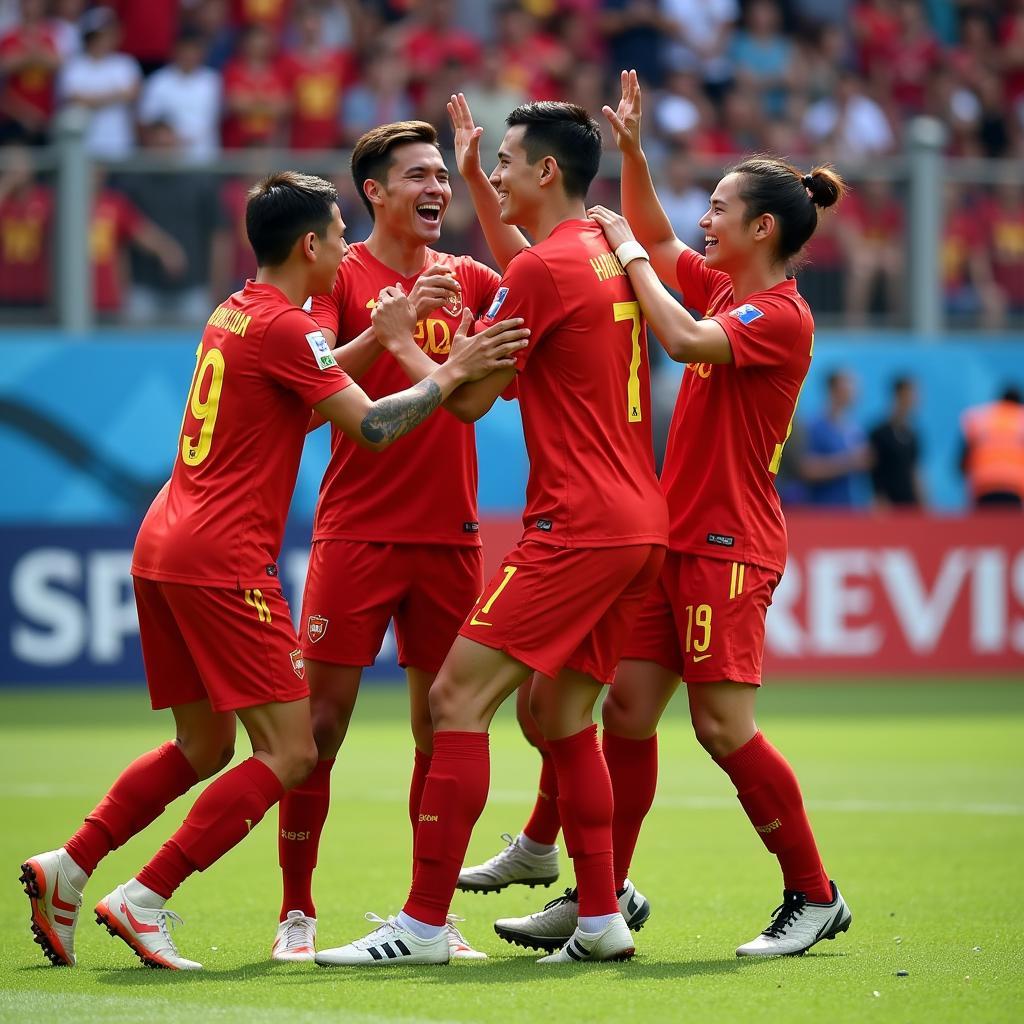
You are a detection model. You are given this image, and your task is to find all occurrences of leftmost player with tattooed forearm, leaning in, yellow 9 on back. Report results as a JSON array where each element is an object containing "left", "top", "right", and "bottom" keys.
[{"left": 22, "top": 167, "right": 521, "bottom": 970}]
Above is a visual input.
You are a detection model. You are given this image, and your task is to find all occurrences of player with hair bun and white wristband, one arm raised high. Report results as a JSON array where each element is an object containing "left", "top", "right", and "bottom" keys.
[{"left": 495, "top": 72, "right": 851, "bottom": 956}]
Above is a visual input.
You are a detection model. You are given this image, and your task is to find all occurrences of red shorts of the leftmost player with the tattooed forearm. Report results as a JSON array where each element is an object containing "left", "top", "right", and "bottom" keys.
[{"left": 134, "top": 577, "right": 309, "bottom": 711}]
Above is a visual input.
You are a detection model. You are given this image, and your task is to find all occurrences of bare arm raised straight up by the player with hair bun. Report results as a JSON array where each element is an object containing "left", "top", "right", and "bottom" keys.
[{"left": 602, "top": 71, "right": 686, "bottom": 282}]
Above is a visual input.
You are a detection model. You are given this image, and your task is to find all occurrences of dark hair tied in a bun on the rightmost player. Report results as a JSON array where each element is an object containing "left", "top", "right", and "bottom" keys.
[{"left": 726, "top": 154, "right": 846, "bottom": 262}]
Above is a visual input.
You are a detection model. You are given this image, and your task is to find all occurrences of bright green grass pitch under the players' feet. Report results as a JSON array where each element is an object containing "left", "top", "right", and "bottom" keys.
[{"left": 0, "top": 682, "right": 1024, "bottom": 1024}]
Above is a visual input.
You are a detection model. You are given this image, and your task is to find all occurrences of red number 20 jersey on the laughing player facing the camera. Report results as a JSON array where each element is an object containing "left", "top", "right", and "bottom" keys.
[{"left": 312, "top": 242, "right": 498, "bottom": 546}]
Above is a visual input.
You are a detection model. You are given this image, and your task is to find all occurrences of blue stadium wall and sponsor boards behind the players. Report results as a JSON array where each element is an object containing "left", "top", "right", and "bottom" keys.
[{"left": 0, "top": 332, "right": 1024, "bottom": 685}]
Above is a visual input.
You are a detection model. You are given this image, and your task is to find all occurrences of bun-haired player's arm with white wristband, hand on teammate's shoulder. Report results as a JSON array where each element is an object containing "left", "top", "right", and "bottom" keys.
[{"left": 587, "top": 206, "right": 732, "bottom": 362}]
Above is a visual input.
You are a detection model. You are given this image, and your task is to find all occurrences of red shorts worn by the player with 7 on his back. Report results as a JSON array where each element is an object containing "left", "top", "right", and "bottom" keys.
[{"left": 459, "top": 541, "right": 665, "bottom": 683}]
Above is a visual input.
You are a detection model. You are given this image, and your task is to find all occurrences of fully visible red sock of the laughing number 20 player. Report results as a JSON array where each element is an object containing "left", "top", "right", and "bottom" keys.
[{"left": 278, "top": 758, "right": 334, "bottom": 921}]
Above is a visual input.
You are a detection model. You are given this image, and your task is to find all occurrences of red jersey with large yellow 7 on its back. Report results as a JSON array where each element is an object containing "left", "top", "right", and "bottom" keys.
[{"left": 477, "top": 220, "right": 668, "bottom": 548}]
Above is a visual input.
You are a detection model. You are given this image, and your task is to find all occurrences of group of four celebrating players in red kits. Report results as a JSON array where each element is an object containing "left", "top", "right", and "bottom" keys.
[{"left": 22, "top": 72, "right": 851, "bottom": 970}]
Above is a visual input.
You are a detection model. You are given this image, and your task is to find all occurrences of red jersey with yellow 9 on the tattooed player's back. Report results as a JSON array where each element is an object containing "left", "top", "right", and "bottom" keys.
[{"left": 132, "top": 281, "right": 352, "bottom": 590}]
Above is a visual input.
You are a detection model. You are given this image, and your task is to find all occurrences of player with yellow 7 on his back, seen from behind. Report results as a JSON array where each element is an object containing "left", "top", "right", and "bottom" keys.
[{"left": 316, "top": 102, "right": 667, "bottom": 967}]
